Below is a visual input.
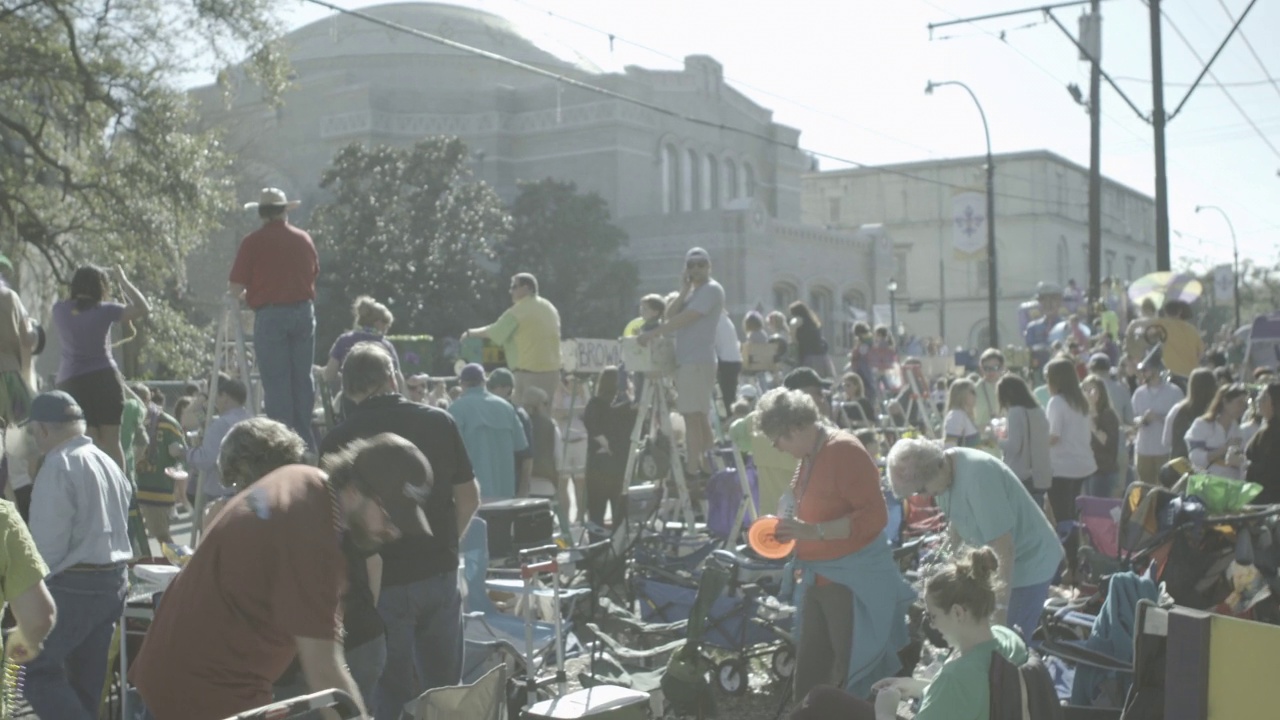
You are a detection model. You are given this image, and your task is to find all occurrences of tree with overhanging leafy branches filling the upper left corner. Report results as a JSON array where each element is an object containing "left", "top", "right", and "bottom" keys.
[{"left": 0, "top": 0, "right": 287, "bottom": 379}]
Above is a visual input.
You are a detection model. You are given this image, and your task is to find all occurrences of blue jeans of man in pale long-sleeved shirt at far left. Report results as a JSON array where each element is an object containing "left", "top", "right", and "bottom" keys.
[{"left": 24, "top": 568, "right": 128, "bottom": 720}]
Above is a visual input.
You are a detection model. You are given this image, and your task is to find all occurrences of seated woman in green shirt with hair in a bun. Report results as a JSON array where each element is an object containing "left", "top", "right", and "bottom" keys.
[{"left": 791, "top": 547, "right": 1028, "bottom": 720}]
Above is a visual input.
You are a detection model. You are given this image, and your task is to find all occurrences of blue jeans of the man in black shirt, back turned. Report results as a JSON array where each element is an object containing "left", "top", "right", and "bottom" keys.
[{"left": 374, "top": 570, "right": 462, "bottom": 720}]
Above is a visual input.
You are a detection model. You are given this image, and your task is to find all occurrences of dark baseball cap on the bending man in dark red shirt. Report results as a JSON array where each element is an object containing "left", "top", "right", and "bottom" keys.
[{"left": 352, "top": 433, "right": 434, "bottom": 536}]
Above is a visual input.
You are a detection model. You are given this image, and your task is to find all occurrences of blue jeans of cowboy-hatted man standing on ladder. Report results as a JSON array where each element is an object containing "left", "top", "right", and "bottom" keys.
[{"left": 253, "top": 300, "right": 316, "bottom": 450}]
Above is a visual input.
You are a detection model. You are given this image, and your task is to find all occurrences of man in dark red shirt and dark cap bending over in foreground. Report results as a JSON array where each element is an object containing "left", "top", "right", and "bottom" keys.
[{"left": 129, "top": 430, "right": 434, "bottom": 720}]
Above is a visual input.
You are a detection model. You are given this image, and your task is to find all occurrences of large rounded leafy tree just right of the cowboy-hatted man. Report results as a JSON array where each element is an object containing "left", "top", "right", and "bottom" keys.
[{"left": 311, "top": 137, "right": 511, "bottom": 351}]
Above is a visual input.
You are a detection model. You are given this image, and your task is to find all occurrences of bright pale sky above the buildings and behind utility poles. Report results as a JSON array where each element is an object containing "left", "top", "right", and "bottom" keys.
[{"left": 241, "top": 0, "right": 1280, "bottom": 266}]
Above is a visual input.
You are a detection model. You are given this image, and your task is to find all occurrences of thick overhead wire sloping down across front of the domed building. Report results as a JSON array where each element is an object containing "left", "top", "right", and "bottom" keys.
[{"left": 296, "top": 0, "right": 1087, "bottom": 208}]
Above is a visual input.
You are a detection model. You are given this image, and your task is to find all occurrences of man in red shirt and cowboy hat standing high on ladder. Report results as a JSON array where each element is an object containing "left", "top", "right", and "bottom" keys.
[{"left": 228, "top": 187, "right": 320, "bottom": 451}]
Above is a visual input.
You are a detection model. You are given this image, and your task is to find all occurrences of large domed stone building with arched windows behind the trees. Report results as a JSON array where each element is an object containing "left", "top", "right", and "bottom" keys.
[{"left": 192, "top": 3, "right": 892, "bottom": 348}]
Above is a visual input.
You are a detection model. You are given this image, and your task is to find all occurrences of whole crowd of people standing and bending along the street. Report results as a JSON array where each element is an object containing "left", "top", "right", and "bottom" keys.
[{"left": 0, "top": 188, "right": 1280, "bottom": 720}]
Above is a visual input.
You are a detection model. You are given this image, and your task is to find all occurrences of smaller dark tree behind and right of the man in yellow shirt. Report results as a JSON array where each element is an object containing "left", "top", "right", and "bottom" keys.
[{"left": 498, "top": 178, "right": 639, "bottom": 338}]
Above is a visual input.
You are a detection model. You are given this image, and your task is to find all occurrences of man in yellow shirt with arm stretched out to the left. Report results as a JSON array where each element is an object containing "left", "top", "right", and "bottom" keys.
[{"left": 462, "top": 273, "right": 561, "bottom": 397}]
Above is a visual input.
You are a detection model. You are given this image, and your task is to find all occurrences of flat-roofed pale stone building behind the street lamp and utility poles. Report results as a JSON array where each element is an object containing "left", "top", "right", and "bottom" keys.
[{"left": 803, "top": 150, "right": 1156, "bottom": 348}]
